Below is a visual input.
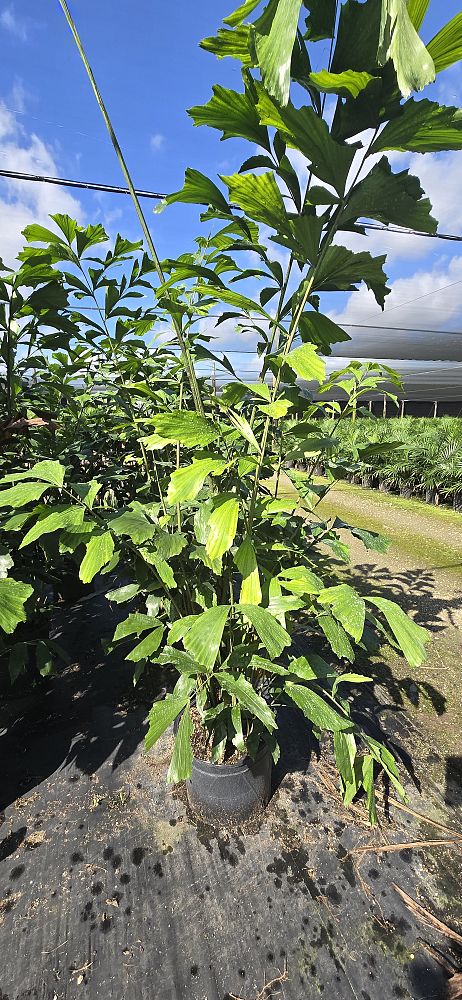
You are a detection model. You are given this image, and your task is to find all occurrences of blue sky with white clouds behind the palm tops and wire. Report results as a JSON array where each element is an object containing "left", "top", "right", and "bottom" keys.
[{"left": 0, "top": 0, "right": 462, "bottom": 390}]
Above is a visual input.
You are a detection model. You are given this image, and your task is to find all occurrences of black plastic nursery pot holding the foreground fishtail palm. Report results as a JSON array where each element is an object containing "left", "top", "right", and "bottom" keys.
[{"left": 186, "top": 745, "right": 273, "bottom": 826}]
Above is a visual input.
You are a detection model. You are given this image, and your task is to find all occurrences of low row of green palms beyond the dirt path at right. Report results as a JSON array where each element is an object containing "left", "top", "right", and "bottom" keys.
[{"left": 308, "top": 416, "right": 462, "bottom": 509}]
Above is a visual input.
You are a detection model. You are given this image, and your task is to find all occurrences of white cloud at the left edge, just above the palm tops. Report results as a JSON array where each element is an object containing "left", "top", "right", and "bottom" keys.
[{"left": 0, "top": 102, "right": 83, "bottom": 265}]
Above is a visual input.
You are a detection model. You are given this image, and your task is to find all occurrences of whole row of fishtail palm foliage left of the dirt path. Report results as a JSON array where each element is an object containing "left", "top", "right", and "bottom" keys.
[{"left": 0, "top": 0, "right": 462, "bottom": 820}]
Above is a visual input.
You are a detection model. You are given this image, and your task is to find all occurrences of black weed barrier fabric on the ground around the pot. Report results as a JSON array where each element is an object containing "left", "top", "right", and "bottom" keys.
[{"left": 0, "top": 597, "right": 462, "bottom": 1000}]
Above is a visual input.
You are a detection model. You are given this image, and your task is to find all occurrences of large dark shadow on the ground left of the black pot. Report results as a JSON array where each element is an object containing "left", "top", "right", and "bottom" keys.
[{"left": 0, "top": 595, "right": 164, "bottom": 809}]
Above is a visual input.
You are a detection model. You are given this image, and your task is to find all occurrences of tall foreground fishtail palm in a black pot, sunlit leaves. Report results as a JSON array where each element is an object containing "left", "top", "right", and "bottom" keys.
[{"left": 0, "top": 0, "right": 462, "bottom": 821}]
